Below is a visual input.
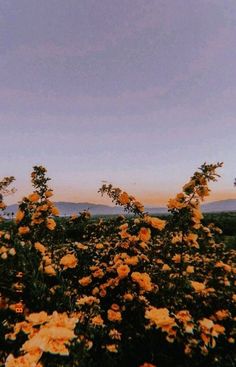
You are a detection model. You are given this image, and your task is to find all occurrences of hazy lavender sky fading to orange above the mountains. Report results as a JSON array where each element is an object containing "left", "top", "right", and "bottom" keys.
[{"left": 0, "top": 0, "right": 236, "bottom": 206}]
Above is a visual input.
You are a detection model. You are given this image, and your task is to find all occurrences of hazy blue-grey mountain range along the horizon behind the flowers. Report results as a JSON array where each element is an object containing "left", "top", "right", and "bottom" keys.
[{"left": 4, "top": 199, "right": 236, "bottom": 216}]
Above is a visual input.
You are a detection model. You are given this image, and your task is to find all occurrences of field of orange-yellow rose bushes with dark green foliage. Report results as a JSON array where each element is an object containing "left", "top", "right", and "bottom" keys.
[{"left": 0, "top": 163, "right": 236, "bottom": 367}]
